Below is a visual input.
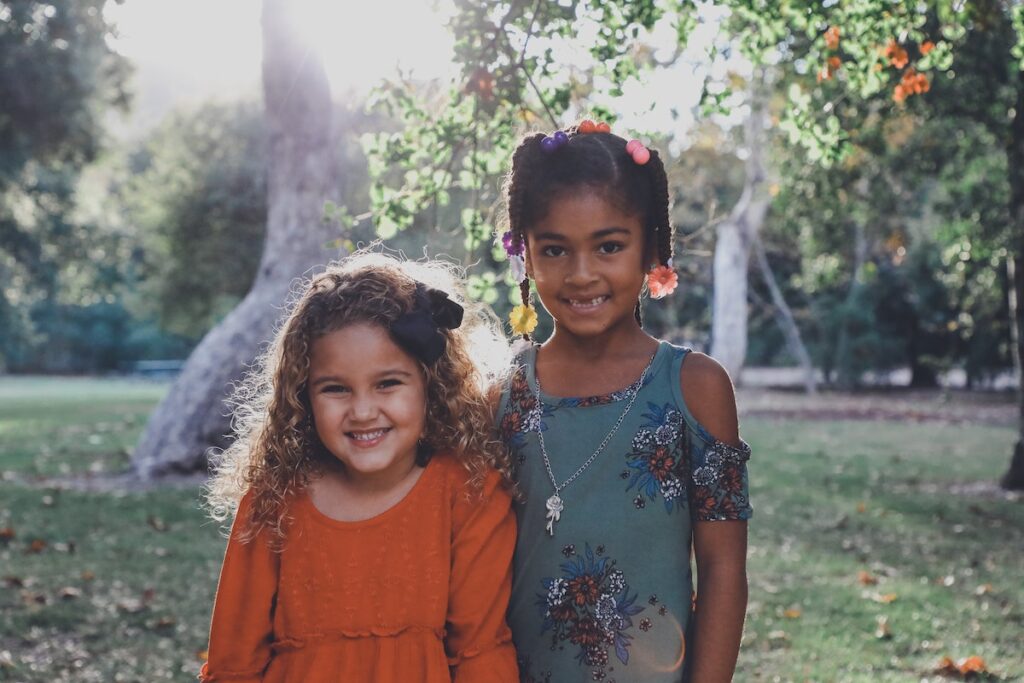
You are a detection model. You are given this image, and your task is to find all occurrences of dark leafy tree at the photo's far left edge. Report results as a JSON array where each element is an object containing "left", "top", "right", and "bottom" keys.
[{"left": 0, "top": 0, "right": 129, "bottom": 368}]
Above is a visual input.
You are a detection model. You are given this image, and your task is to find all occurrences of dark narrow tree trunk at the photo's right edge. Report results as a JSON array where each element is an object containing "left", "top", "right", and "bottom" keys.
[{"left": 1000, "top": 71, "right": 1024, "bottom": 490}]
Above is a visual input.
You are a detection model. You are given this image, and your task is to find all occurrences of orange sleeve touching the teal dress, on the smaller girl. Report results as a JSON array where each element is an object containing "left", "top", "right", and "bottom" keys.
[{"left": 445, "top": 472, "right": 519, "bottom": 683}]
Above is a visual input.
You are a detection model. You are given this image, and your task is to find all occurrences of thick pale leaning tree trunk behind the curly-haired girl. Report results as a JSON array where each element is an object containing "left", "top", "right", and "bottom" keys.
[{"left": 133, "top": 0, "right": 338, "bottom": 478}]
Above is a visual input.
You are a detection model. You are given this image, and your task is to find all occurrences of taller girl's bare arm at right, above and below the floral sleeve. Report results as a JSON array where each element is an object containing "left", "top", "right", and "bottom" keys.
[{"left": 680, "top": 353, "right": 746, "bottom": 683}]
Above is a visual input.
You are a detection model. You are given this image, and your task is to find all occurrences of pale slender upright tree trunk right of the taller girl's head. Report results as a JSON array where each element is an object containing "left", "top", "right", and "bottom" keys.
[{"left": 711, "top": 83, "right": 769, "bottom": 384}]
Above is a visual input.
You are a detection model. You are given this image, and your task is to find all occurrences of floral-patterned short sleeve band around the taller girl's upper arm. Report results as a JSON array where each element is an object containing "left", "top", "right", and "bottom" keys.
[{"left": 687, "top": 439, "right": 751, "bottom": 521}]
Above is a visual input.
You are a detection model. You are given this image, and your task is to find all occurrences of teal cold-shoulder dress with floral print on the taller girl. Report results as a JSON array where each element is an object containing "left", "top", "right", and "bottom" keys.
[{"left": 497, "top": 342, "right": 751, "bottom": 683}]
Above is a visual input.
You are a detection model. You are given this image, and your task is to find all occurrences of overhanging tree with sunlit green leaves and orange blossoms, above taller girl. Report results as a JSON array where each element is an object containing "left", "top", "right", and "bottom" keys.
[{"left": 356, "top": 0, "right": 1024, "bottom": 486}]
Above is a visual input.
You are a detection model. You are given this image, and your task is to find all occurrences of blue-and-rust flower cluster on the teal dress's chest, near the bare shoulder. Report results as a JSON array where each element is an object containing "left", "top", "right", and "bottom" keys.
[{"left": 626, "top": 402, "right": 689, "bottom": 512}]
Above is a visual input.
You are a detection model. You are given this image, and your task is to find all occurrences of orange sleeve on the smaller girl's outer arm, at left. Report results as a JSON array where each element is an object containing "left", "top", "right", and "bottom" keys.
[{"left": 200, "top": 494, "right": 280, "bottom": 683}]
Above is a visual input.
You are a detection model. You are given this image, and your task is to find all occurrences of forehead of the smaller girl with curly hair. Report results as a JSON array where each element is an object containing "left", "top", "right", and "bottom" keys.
[{"left": 309, "top": 323, "right": 420, "bottom": 381}]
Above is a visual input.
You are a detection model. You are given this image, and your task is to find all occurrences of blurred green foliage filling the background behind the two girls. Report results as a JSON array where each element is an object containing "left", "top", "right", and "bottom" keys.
[{"left": 0, "top": 0, "right": 1017, "bottom": 386}]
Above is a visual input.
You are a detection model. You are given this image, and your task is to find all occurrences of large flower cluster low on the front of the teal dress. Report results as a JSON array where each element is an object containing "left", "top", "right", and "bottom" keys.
[{"left": 537, "top": 544, "right": 644, "bottom": 680}]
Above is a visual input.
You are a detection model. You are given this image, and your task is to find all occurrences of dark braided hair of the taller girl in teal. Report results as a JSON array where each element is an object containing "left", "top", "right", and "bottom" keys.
[{"left": 504, "top": 124, "right": 675, "bottom": 341}]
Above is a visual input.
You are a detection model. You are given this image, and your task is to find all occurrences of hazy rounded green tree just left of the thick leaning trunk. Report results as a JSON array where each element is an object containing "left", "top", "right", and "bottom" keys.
[{"left": 122, "top": 102, "right": 267, "bottom": 340}]
